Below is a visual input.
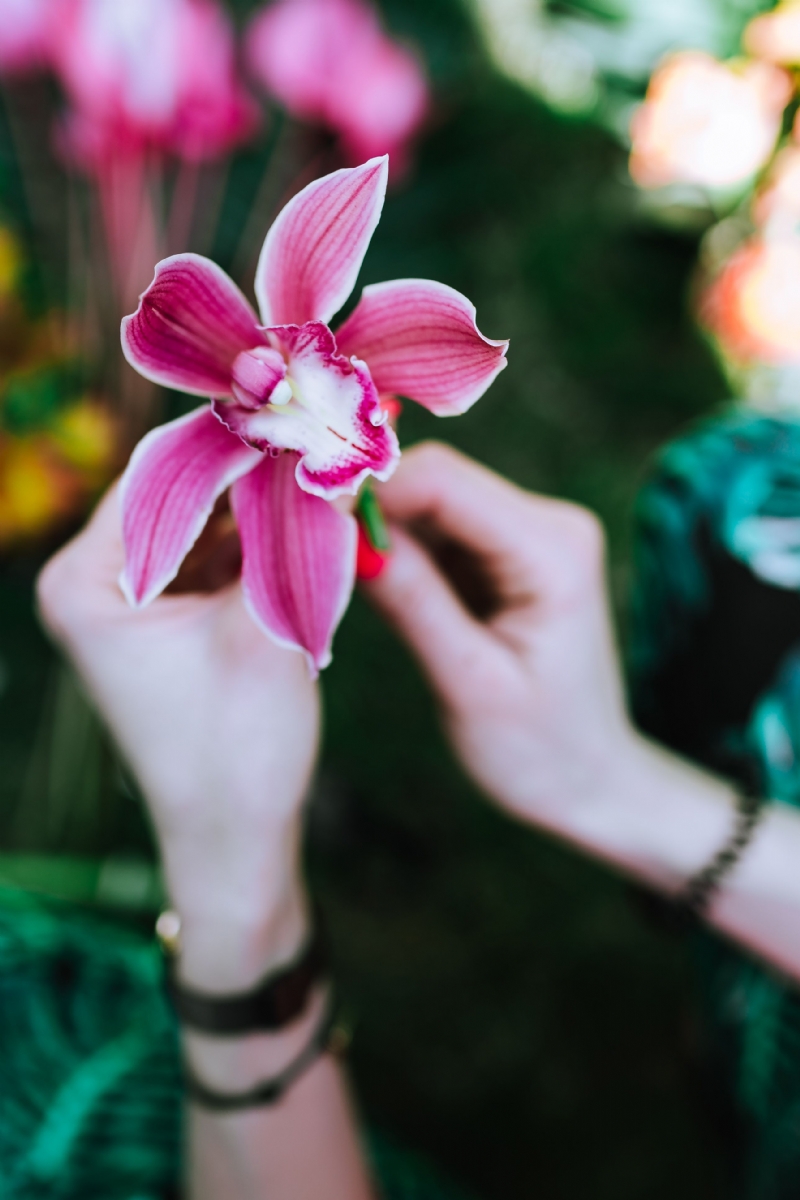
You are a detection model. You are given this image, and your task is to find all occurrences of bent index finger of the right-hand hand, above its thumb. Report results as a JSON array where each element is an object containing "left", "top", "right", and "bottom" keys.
[{"left": 380, "top": 442, "right": 603, "bottom": 605}]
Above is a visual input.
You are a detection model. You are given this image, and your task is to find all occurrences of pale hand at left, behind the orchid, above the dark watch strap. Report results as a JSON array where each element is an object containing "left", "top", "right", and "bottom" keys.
[{"left": 38, "top": 488, "right": 319, "bottom": 991}]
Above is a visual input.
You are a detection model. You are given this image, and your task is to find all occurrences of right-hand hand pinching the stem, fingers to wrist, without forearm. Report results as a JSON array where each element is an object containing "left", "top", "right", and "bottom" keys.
[{"left": 368, "top": 443, "right": 633, "bottom": 820}]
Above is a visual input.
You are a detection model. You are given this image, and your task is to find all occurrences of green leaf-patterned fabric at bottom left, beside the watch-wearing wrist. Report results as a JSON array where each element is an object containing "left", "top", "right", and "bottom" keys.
[{"left": 0, "top": 888, "right": 474, "bottom": 1200}]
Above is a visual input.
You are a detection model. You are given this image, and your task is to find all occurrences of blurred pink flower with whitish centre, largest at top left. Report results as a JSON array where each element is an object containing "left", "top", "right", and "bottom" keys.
[{"left": 52, "top": 0, "right": 257, "bottom": 167}]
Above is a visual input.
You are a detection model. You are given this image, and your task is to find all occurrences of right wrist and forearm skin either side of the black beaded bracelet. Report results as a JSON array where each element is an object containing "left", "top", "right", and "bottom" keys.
[{"left": 534, "top": 736, "right": 800, "bottom": 980}]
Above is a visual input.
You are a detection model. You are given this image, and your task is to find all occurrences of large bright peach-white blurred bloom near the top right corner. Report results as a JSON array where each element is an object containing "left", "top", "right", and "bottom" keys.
[{"left": 630, "top": 50, "right": 792, "bottom": 187}]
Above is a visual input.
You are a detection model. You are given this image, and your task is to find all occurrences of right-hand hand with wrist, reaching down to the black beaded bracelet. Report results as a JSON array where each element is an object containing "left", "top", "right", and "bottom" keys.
[{"left": 366, "top": 443, "right": 730, "bottom": 889}]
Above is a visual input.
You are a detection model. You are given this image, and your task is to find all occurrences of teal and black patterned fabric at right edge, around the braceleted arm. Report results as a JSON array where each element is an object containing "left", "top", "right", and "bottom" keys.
[{"left": 631, "top": 410, "right": 800, "bottom": 1200}]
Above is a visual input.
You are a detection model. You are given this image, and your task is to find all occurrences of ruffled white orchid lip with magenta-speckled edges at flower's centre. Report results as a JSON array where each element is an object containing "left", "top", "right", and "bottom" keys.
[{"left": 213, "top": 322, "right": 399, "bottom": 500}]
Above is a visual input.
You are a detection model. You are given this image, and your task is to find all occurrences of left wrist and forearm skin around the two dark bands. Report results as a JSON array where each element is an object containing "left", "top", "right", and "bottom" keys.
[{"left": 164, "top": 829, "right": 373, "bottom": 1200}]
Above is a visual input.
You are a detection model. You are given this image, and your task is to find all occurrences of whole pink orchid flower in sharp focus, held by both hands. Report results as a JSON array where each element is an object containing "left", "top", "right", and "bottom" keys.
[{"left": 121, "top": 157, "right": 507, "bottom": 672}]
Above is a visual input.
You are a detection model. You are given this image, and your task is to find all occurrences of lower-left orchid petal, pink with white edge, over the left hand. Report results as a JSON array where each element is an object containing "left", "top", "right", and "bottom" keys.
[{"left": 120, "top": 404, "right": 261, "bottom": 608}]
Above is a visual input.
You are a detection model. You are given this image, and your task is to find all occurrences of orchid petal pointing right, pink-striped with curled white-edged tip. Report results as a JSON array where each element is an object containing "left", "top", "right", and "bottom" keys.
[{"left": 336, "top": 280, "right": 509, "bottom": 416}]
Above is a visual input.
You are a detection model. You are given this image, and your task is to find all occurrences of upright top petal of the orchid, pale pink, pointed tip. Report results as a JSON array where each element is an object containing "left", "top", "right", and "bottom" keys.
[{"left": 255, "top": 156, "right": 389, "bottom": 325}]
